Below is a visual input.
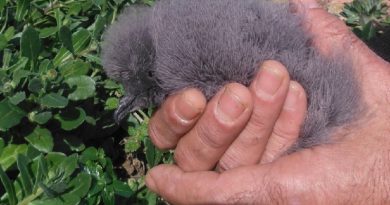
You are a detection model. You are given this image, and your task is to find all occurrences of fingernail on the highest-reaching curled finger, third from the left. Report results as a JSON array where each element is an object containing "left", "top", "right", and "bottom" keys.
[{"left": 256, "top": 67, "right": 283, "bottom": 98}]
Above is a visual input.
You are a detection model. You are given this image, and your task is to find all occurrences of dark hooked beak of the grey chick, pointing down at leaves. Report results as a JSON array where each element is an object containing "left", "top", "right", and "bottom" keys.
[{"left": 114, "top": 94, "right": 148, "bottom": 124}]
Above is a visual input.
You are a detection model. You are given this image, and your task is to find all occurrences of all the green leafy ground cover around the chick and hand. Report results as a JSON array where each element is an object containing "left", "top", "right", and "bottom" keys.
[{"left": 0, "top": 0, "right": 390, "bottom": 205}]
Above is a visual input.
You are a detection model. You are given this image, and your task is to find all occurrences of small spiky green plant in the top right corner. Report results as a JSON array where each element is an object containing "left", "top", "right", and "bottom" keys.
[{"left": 341, "top": 0, "right": 390, "bottom": 41}]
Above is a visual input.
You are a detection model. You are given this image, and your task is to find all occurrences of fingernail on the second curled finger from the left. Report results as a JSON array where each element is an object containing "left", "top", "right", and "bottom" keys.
[{"left": 217, "top": 87, "right": 246, "bottom": 121}]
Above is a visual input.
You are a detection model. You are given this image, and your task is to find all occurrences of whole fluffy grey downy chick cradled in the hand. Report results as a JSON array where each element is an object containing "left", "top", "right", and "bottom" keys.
[{"left": 103, "top": 0, "right": 360, "bottom": 149}]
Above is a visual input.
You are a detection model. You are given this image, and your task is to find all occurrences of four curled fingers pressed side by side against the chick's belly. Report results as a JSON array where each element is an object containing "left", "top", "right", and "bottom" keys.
[{"left": 149, "top": 58, "right": 306, "bottom": 171}]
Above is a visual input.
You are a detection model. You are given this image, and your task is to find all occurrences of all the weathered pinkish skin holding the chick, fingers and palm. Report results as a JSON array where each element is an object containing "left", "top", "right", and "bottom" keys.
[{"left": 146, "top": 0, "right": 390, "bottom": 204}]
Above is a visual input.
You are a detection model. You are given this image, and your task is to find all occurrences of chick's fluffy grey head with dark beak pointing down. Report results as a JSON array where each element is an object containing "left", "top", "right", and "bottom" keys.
[{"left": 102, "top": 7, "right": 160, "bottom": 123}]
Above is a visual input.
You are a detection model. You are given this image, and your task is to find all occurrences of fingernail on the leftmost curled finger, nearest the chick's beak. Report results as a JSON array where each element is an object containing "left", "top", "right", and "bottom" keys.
[{"left": 175, "top": 91, "right": 203, "bottom": 121}]
